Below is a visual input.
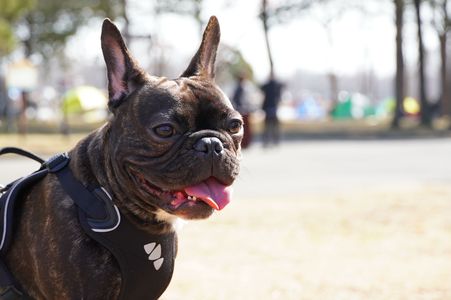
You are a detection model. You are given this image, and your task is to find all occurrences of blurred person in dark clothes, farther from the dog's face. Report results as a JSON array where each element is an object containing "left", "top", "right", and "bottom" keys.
[{"left": 261, "top": 72, "right": 283, "bottom": 147}]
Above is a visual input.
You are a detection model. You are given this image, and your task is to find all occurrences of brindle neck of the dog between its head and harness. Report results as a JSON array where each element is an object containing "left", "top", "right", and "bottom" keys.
[{"left": 70, "top": 124, "right": 178, "bottom": 233}]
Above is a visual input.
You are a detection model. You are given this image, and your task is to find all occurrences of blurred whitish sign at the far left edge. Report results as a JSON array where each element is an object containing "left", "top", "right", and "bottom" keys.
[{"left": 6, "top": 59, "right": 38, "bottom": 91}]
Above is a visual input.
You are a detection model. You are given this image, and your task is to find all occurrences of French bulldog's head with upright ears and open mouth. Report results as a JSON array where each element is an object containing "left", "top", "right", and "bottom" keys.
[{"left": 101, "top": 17, "right": 243, "bottom": 223}]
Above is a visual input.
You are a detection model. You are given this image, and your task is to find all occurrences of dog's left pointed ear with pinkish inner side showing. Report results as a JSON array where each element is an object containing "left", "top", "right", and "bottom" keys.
[{"left": 100, "top": 19, "right": 145, "bottom": 110}]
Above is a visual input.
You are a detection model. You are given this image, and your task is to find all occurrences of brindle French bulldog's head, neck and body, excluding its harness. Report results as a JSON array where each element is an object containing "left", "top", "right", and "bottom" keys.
[{"left": 6, "top": 17, "right": 243, "bottom": 299}]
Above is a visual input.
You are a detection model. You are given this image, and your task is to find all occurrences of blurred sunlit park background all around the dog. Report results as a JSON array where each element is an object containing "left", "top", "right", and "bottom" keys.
[{"left": 0, "top": 0, "right": 451, "bottom": 299}]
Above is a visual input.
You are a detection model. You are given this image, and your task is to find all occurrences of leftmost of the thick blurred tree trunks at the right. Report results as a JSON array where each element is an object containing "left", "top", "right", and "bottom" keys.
[{"left": 391, "top": 0, "right": 405, "bottom": 129}]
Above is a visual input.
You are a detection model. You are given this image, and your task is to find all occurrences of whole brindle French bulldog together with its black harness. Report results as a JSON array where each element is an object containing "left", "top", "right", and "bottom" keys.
[{"left": 0, "top": 17, "right": 242, "bottom": 299}]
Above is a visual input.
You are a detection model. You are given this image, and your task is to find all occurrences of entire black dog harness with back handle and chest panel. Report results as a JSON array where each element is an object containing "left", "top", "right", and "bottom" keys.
[{"left": 0, "top": 147, "right": 176, "bottom": 299}]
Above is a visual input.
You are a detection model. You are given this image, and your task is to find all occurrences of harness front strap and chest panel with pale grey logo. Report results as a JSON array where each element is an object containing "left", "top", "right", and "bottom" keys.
[{"left": 46, "top": 154, "right": 176, "bottom": 300}]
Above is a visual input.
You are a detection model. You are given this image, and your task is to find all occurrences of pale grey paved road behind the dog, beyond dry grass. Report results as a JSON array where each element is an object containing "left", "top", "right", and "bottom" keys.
[{"left": 0, "top": 139, "right": 451, "bottom": 198}]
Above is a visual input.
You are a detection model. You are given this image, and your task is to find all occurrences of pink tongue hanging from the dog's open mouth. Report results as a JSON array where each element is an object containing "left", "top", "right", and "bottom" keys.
[{"left": 185, "top": 177, "right": 232, "bottom": 210}]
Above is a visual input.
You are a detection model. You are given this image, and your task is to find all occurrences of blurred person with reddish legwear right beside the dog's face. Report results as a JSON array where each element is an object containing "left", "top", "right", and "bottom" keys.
[{"left": 231, "top": 74, "right": 252, "bottom": 149}]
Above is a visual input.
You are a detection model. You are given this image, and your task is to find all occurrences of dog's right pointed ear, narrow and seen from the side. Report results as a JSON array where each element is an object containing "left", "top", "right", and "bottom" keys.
[{"left": 181, "top": 16, "right": 221, "bottom": 80}]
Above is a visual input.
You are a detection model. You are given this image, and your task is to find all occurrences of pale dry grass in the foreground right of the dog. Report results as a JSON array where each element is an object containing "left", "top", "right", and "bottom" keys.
[{"left": 163, "top": 186, "right": 451, "bottom": 300}]
